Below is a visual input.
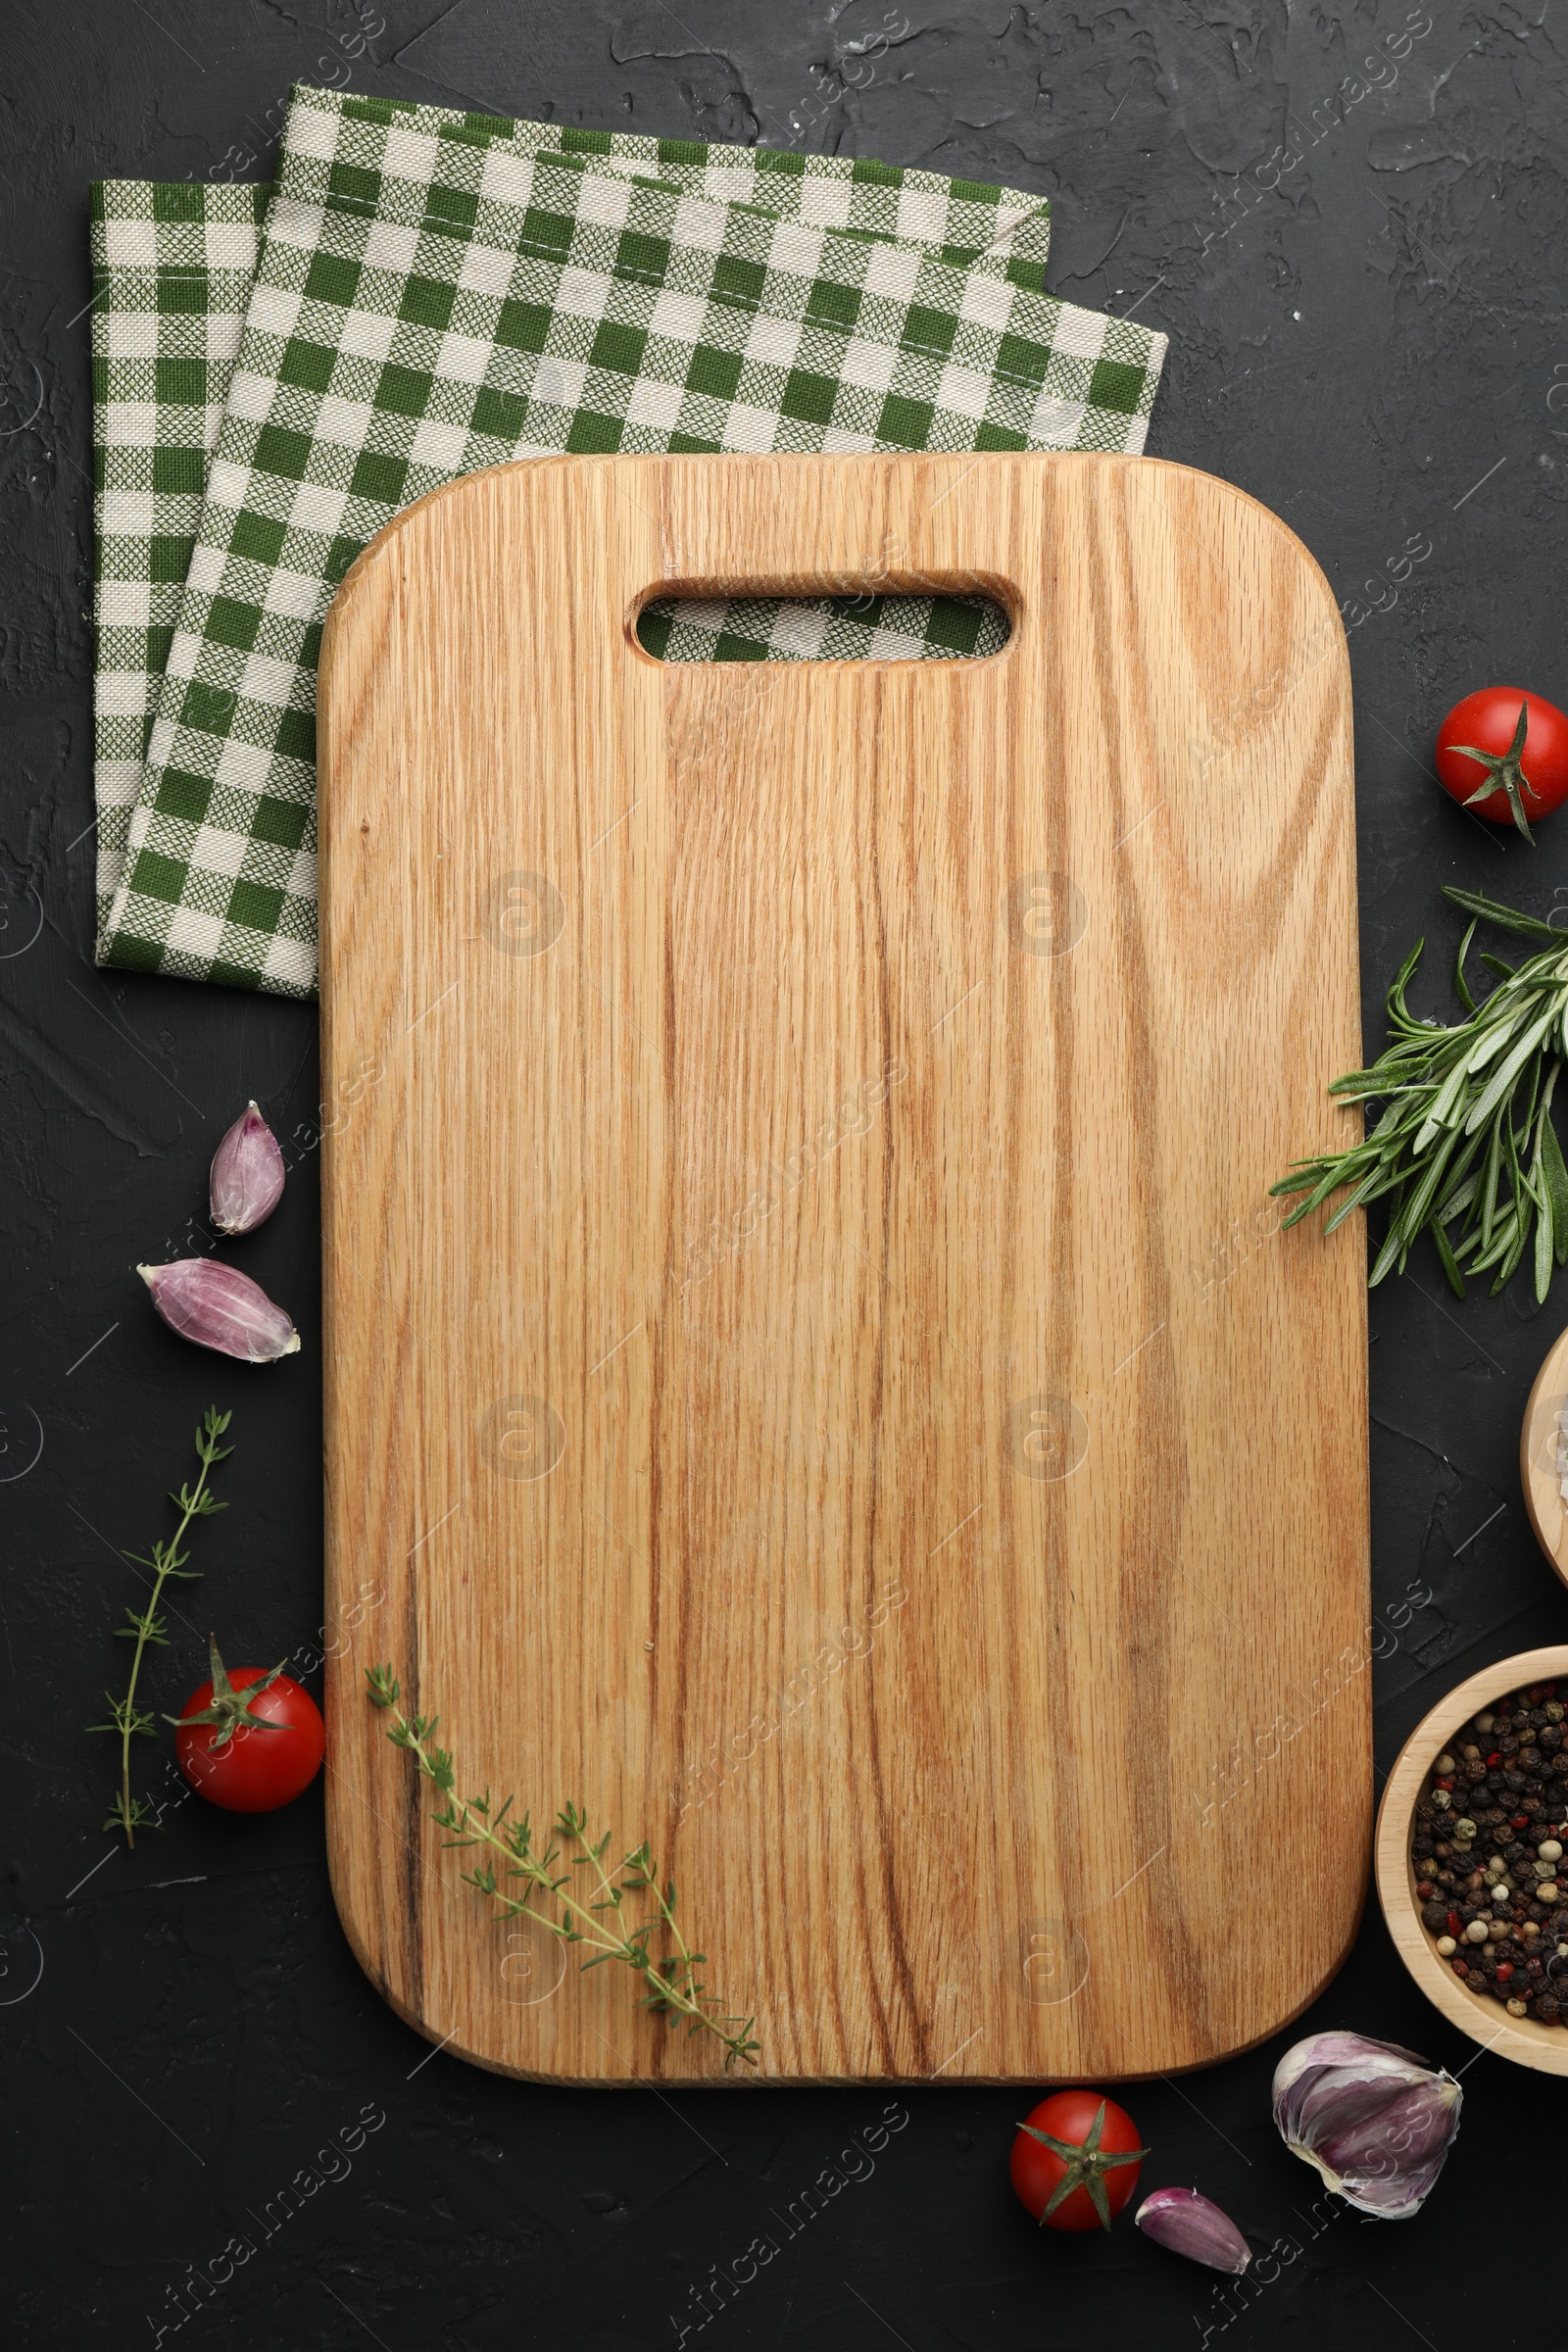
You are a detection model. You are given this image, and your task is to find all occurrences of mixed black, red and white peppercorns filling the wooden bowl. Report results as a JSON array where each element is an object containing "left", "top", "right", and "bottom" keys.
[{"left": 1410, "top": 1682, "right": 1568, "bottom": 2025}]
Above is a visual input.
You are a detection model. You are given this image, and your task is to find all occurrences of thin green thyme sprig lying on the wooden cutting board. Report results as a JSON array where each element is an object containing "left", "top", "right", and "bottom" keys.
[{"left": 365, "top": 1665, "right": 761, "bottom": 2068}]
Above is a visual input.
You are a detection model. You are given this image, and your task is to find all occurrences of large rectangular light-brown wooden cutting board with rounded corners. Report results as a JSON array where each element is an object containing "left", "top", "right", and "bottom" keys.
[{"left": 319, "top": 454, "right": 1371, "bottom": 2083}]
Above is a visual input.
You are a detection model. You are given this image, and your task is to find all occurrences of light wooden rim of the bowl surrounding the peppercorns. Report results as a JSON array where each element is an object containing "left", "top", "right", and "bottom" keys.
[{"left": 1375, "top": 1655, "right": 1568, "bottom": 2075}]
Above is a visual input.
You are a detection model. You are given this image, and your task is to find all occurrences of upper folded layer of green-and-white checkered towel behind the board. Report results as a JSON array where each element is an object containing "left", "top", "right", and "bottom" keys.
[{"left": 106, "top": 89, "right": 1163, "bottom": 998}]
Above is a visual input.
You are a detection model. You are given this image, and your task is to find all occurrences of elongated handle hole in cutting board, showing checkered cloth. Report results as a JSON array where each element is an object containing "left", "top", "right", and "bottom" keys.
[{"left": 637, "top": 583, "right": 1013, "bottom": 661}]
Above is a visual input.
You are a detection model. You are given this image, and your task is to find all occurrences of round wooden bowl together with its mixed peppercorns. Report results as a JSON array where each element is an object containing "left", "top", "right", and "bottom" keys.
[{"left": 1378, "top": 1648, "right": 1568, "bottom": 2075}]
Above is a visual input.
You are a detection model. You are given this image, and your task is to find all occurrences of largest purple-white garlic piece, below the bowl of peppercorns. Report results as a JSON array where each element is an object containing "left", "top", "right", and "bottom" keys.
[{"left": 1274, "top": 2033, "right": 1464, "bottom": 2221}]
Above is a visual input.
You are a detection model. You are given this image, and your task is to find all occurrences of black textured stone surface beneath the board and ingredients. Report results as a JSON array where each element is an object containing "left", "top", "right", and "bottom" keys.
[{"left": 0, "top": 0, "right": 1568, "bottom": 2352}]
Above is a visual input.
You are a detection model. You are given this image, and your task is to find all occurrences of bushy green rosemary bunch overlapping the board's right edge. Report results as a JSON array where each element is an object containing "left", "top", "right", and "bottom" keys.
[{"left": 1269, "top": 887, "right": 1568, "bottom": 1300}]
